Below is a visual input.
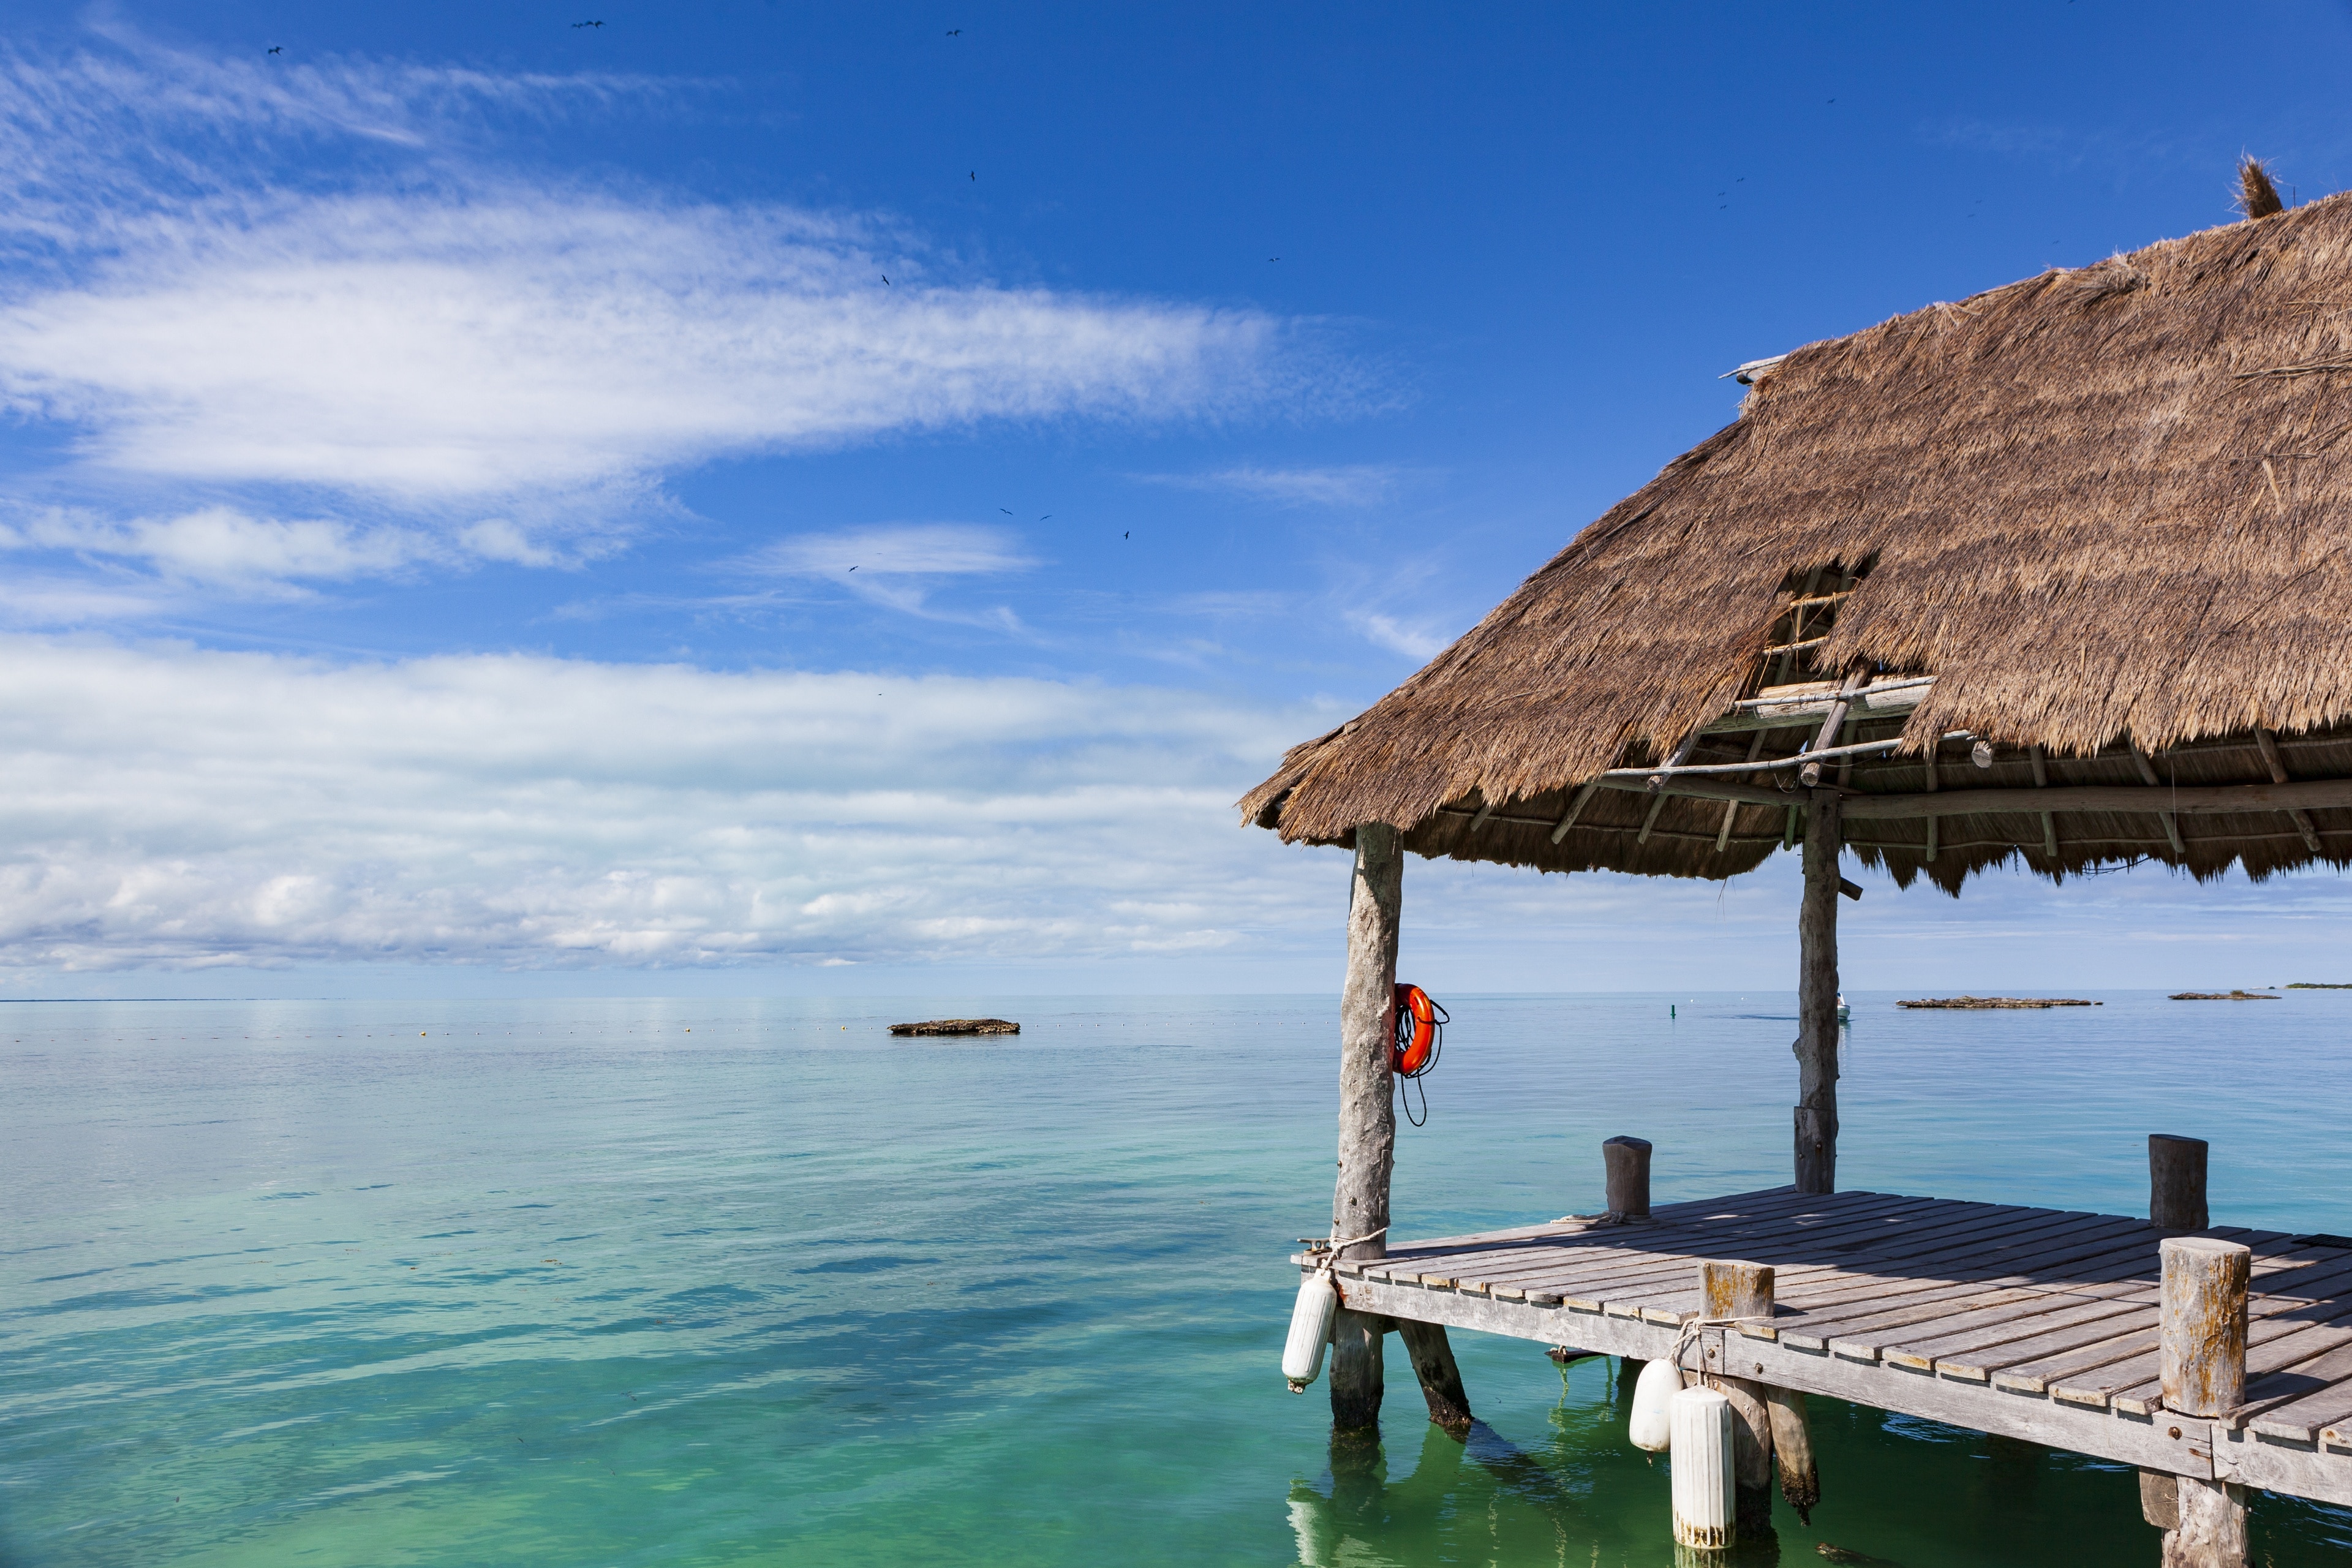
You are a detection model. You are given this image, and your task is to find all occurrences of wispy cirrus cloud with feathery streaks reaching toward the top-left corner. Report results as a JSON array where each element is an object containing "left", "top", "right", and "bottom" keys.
[{"left": 0, "top": 36, "right": 1345, "bottom": 606}]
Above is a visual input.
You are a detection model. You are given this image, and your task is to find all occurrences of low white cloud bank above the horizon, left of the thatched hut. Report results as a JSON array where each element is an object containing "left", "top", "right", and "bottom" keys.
[{"left": 0, "top": 637, "right": 1331, "bottom": 971}]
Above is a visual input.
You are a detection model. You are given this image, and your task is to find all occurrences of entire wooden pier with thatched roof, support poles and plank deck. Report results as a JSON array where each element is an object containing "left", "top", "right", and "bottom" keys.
[{"left": 1237, "top": 162, "right": 2352, "bottom": 1568}]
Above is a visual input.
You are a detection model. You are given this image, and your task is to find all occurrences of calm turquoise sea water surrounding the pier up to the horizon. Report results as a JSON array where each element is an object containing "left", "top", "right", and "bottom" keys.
[{"left": 0, "top": 992, "right": 2352, "bottom": 1568}]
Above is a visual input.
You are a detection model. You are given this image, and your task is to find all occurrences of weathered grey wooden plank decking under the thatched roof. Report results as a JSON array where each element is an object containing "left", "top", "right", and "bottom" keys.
[{"left": 1298, "top": 1187, "right": 2352, "bottom": 1504}]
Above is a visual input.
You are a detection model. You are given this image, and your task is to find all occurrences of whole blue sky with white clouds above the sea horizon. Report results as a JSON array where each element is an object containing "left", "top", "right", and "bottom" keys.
[{"left": 0, "top": 0, "right": 2352, "bottom": 995}]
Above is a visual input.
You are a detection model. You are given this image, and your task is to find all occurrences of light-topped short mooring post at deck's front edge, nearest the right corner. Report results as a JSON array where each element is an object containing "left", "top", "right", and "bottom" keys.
[{"left": 2140, "top": 1237, "right": 2253, "bottom": 1568}]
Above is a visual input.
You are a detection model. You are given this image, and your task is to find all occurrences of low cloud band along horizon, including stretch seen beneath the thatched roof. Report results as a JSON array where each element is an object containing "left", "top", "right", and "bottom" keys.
[{"left": 0, "top": 637, "right": 2352, "bottom": 992}]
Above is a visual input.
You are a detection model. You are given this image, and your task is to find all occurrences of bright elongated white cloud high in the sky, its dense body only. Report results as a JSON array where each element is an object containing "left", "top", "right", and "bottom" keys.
[{"left": 0, "top": 195, "right": 1280, "bottom": 505}]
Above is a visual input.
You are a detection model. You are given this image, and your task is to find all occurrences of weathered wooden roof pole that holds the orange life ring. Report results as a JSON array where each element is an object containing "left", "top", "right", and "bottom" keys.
[{"left": 1331, "top": 823, "right": 1404, "bottom": 1430}]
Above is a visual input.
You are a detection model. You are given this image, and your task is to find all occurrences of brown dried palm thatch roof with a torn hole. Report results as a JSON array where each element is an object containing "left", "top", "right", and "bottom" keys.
[{"left": 1240, "top": 186, "right": 2352, "bottom": 891}]
